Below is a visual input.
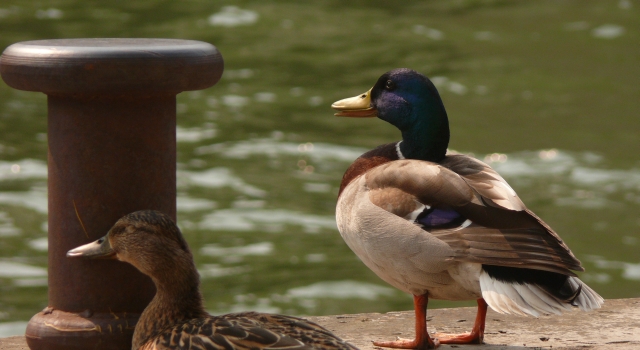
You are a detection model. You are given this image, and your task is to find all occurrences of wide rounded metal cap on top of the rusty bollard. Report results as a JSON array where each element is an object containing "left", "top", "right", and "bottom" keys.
[{"left": 0, "top": 39, "right": 223, "bottom": 96}]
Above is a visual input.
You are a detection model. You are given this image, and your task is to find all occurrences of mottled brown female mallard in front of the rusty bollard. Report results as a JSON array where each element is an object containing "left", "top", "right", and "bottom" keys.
[{"left": 67, "top": 210, "right": 357, "bottom": 350}]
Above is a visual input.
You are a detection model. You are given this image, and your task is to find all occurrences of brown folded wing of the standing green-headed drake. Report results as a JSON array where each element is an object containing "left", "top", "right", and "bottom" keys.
[{"left": 365, "top": 157, "right": 583, "bottom": 275}]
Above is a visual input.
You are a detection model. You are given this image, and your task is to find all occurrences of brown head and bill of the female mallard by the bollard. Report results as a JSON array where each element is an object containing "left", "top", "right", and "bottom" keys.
[{"left": 67, "top": 210, "right": 193, "bottom": 277}]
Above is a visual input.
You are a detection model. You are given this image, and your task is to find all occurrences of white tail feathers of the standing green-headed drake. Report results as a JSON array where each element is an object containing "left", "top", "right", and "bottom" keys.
[{"left": 479, "top": 271, "right": 604, "bottom": 317}]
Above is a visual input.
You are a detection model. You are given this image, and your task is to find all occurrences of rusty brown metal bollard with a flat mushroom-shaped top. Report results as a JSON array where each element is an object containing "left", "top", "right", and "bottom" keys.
[{"left": 0, "top": 39, "right": 223, "bottom": 349}]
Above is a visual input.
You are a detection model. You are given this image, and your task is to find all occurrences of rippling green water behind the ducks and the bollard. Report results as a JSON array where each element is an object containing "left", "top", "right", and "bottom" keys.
[{"left": 0, "top": 0, "right": 640, "bottom": 334}]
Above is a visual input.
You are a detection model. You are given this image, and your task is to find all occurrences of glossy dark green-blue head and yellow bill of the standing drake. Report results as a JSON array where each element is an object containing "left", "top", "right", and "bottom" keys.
[{"left": 331, "top": 68, "right": 449, "bottom": 161}]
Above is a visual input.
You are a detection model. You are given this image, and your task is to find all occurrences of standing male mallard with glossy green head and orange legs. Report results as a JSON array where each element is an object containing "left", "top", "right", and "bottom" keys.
[{"left": 332, "top": 69, "right": 604, "bottom": 349}]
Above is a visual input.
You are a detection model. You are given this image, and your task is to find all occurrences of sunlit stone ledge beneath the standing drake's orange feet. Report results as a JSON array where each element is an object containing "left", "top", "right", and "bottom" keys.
[{"left": 0, "top": 298, "right": 640, "bottom": 350}]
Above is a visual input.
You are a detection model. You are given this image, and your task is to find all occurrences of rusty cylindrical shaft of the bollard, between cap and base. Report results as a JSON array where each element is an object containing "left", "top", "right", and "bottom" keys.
[{"left": 48, "top": 96, "right": 176, "bottom": 313}]
